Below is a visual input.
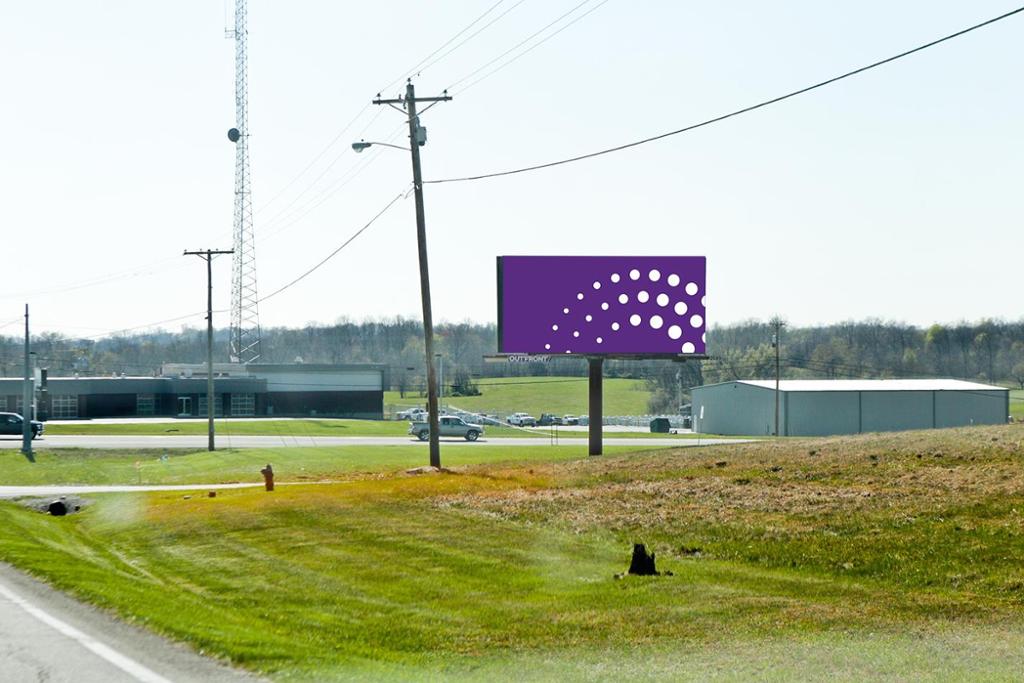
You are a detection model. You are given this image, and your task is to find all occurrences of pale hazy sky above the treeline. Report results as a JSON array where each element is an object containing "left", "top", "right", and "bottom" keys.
[{"left": 0, "top": 0, "right": 1024, "bottom": 336}]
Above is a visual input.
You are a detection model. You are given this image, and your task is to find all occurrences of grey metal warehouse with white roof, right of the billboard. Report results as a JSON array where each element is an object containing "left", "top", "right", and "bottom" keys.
[{"left": 692, "top": 380, "right": 1010, "bottom": 436}]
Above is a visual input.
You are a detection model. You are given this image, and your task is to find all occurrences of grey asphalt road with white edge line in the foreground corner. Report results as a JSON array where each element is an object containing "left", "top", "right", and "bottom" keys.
[{"left": 0, "top": 563, "right": 258, "bottom": 683}]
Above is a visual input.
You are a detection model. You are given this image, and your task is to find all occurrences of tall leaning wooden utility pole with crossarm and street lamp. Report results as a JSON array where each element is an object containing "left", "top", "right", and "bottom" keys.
[{"left": 374, "top": 81, "right": 452, "bottom": 467}]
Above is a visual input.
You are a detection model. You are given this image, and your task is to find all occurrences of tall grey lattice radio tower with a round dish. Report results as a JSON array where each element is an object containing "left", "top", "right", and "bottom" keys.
[{"left": 225, "top": 0, "right": 260, "bottom": 362}]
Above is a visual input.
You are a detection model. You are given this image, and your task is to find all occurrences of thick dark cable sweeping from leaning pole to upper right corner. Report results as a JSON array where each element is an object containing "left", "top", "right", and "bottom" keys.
[{"left": 424, "top": 7, "right": 1024, "bottom": 184}]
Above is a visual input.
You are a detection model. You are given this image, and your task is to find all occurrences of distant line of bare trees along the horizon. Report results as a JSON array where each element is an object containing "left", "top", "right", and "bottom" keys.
[{"left": 0, "top": 317, "right": 1024, "bottom": 412}]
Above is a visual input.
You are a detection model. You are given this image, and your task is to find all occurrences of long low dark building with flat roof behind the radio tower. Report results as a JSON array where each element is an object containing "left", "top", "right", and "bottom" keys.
[{"left": 0, "top": 364, "right": 388, "bottom": 420}]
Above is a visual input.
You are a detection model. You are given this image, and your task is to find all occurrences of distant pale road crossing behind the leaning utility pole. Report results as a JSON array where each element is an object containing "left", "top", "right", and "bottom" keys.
[{"left": 0, "top": 434, "right": 748, "bottom": 450}]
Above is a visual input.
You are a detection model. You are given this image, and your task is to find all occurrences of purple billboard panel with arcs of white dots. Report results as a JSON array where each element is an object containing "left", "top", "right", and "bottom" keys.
[{"left": 498, "top": 256, "right": 707, "bottom": 356}]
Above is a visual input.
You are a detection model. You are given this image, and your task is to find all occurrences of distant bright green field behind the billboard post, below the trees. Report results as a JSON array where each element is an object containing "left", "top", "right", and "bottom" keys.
[{"left": 384, "top": 377, "right": 650, "bottom": 417}]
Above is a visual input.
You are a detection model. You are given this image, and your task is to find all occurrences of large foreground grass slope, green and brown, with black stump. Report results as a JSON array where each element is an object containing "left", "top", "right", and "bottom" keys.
[{"left": 0, "top": 425, "right": 1024, "bottom": 681}]
